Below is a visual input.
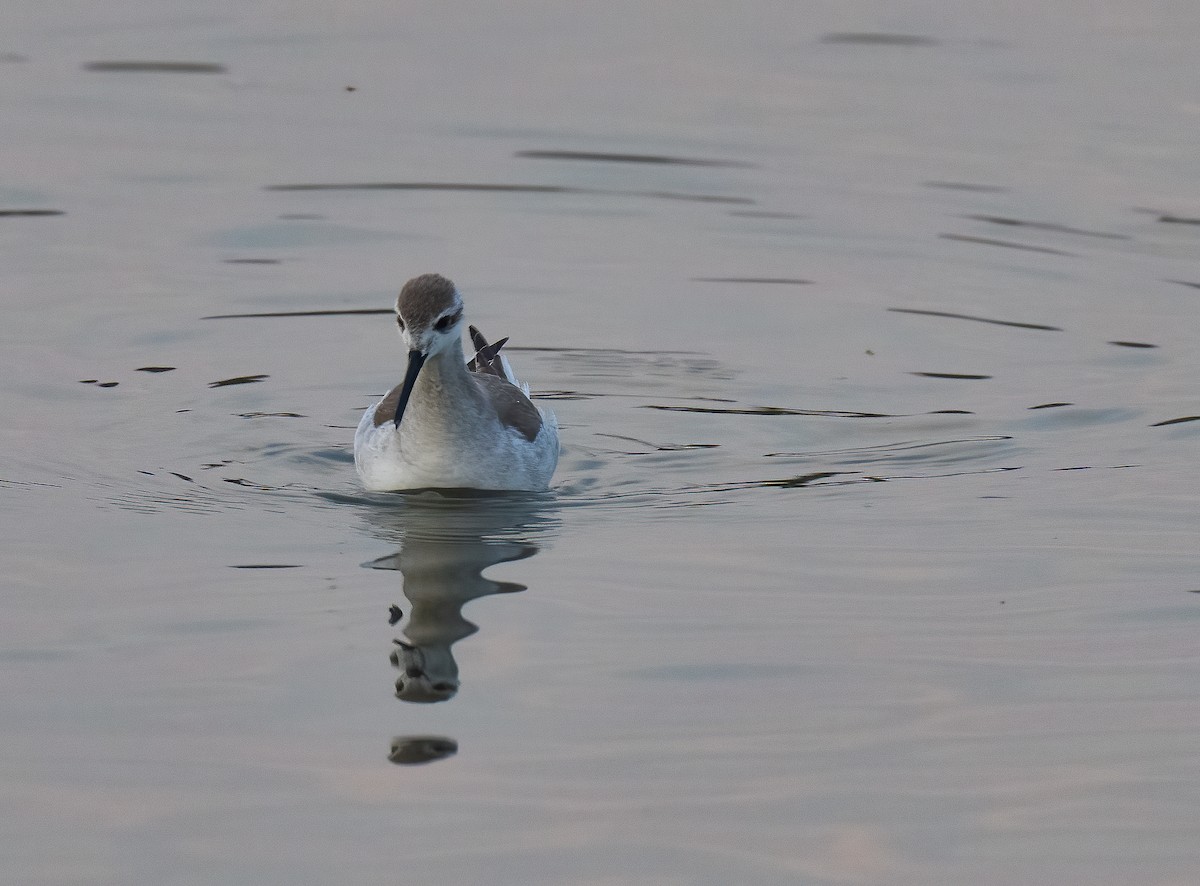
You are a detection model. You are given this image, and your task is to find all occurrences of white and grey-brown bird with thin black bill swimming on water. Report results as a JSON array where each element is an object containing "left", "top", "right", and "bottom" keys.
[{"left": 354, "top": 274, "right": 558, "bottom": 492}]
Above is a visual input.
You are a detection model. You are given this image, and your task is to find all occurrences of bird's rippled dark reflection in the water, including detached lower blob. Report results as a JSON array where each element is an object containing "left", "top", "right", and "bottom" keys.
[{"left": 355, "top": 493, "right": 558, "bottom": 764}]
